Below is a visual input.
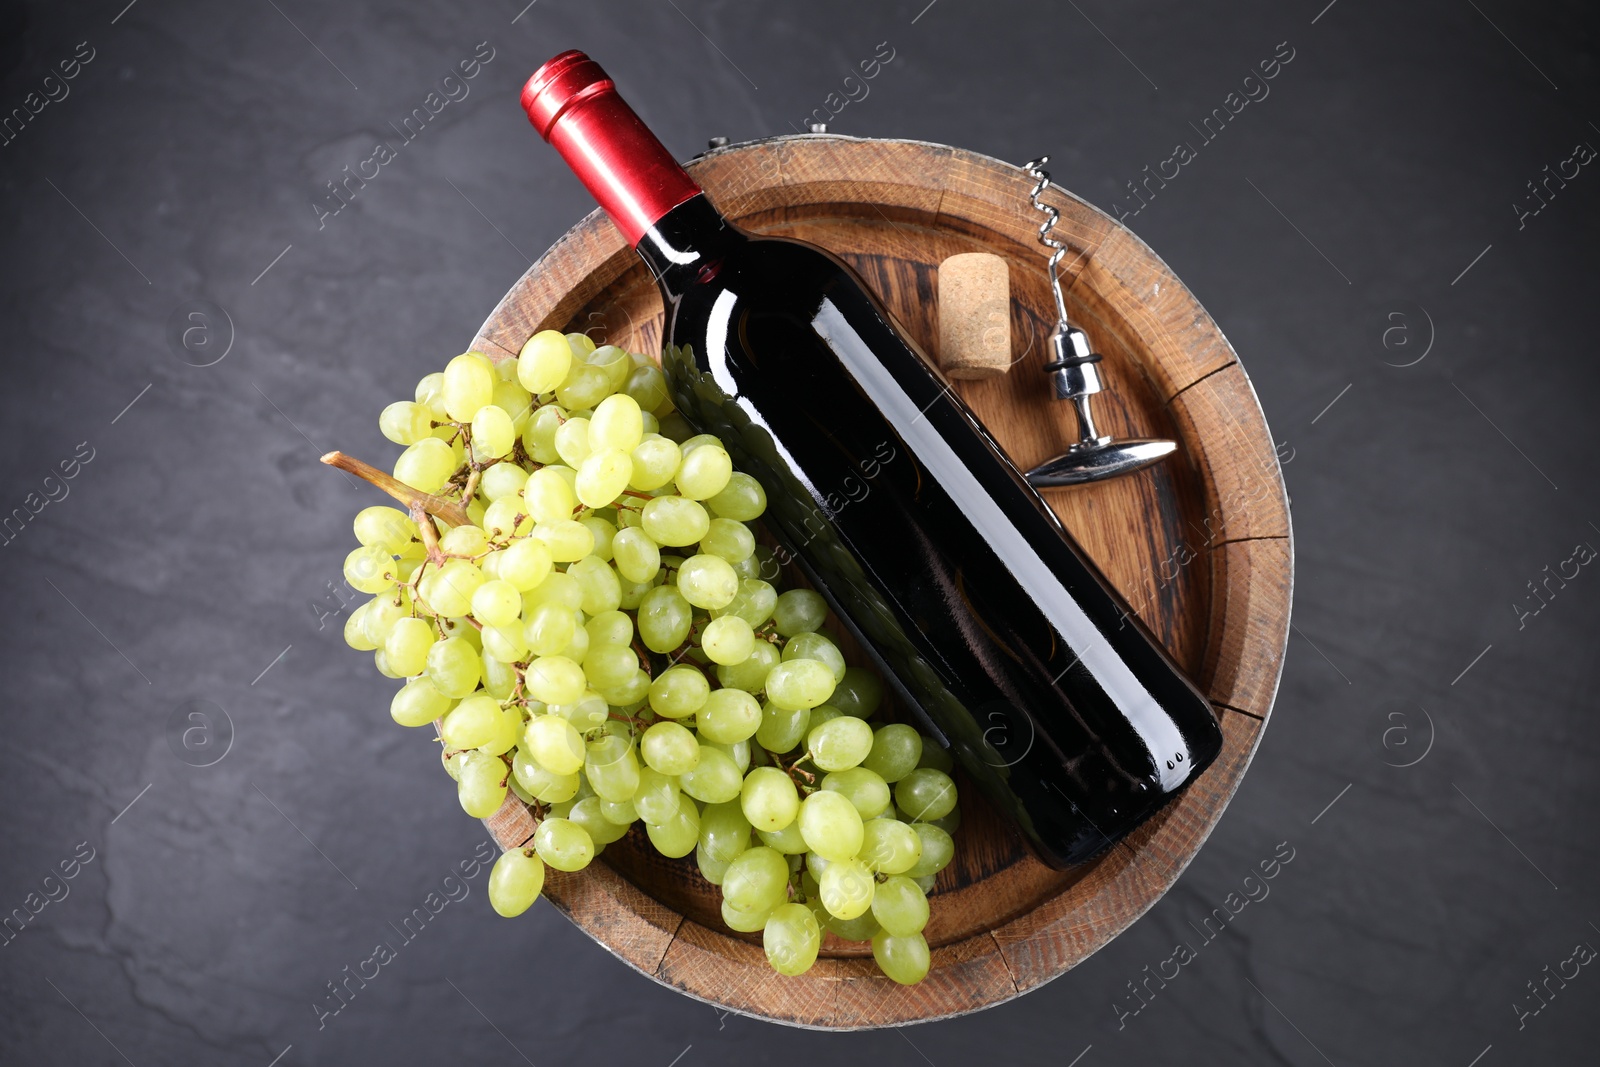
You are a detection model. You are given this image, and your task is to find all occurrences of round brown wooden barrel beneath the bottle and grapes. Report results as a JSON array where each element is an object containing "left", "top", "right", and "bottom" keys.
[{"left": 460, "top": 134, "right": 1293, "bottom": 1030}]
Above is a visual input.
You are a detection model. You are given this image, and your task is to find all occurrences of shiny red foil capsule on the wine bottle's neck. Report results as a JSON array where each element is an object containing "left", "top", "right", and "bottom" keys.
[{"left": 522, "top": 51, "right": 701, "bottom": 245}]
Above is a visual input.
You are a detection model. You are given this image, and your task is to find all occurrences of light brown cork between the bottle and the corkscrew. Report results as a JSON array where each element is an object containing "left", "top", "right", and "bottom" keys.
[{"left": 939, "top": 251, "right": 1011, "bottom": 379}]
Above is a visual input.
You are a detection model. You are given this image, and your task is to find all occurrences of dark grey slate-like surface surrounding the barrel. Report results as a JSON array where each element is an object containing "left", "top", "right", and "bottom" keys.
[{"left": 0, "top": 0, "right": 1600, "bottom": 1067}]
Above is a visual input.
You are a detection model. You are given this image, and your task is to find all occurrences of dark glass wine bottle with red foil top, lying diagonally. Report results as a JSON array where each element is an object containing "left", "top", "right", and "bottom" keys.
[{"left": 522, "top": 51, "right": 1222, "bottom": 867}]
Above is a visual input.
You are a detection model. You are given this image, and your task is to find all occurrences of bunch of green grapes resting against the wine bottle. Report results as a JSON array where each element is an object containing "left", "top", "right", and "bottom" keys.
[{"left": 346, "top": 331, "right": 960, "bottom": 984}]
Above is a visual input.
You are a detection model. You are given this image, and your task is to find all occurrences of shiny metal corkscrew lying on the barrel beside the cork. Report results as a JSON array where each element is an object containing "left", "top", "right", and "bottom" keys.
[{"left": 1024, "top": 155, "right": 1178, "bottom": 490}]
